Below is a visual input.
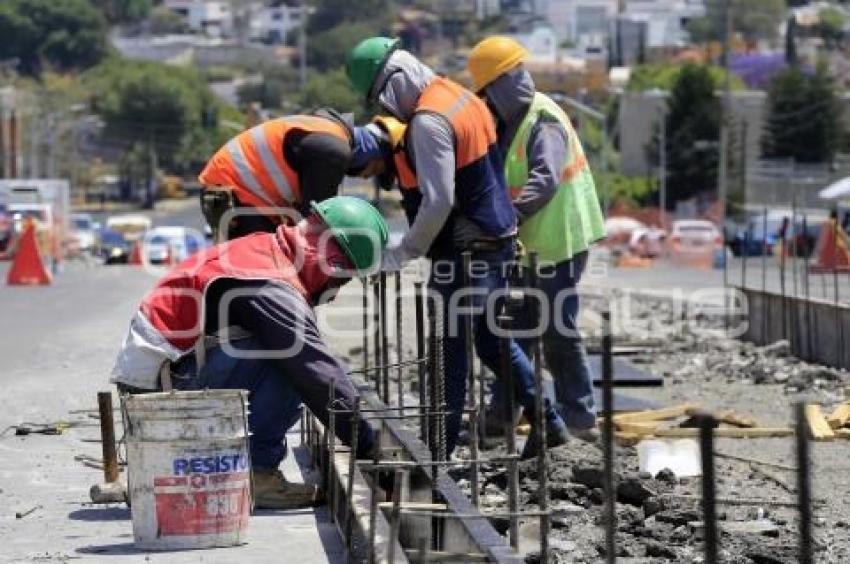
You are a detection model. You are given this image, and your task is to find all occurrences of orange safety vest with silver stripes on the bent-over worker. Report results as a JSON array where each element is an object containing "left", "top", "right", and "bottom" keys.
[{"left": 198, "top": 115, "right": 350, "bottom": 212}]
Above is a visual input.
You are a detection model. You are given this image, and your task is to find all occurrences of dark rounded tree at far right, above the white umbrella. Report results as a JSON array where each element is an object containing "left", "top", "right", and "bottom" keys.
[{"left": 762, "top": 66, "right": 843, "bottom": 163}]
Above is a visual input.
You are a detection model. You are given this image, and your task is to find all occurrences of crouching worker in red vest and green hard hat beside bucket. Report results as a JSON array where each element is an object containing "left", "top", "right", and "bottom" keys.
[{"left": 113, "top": 196, "right": 388, "bottom": 509}]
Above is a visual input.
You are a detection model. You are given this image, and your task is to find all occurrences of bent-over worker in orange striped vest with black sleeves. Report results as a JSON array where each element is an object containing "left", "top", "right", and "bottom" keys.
[{"left": 198, "top": 109, "right": 386, "bottom": 241}]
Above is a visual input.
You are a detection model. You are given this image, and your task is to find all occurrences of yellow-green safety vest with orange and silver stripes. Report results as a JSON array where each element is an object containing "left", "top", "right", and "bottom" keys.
[{"left": 505, "top": 92, "right": 605, "bottom": 263}]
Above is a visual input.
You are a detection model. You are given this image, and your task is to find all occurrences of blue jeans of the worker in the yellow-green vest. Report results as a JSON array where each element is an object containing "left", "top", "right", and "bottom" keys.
[{"left": 510, "top": 252, "right": 596, "bottom": 429}]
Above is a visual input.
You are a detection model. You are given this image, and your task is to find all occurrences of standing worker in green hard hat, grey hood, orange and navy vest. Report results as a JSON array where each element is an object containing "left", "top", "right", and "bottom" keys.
[{"left": 346, "top": 37, "right": 566, "bottom": 456}]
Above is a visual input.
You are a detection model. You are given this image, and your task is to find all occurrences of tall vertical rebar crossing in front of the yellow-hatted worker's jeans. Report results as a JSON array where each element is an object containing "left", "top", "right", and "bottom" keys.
[{"left": 528, "top": 251, "right": 550, "bottom": 564}]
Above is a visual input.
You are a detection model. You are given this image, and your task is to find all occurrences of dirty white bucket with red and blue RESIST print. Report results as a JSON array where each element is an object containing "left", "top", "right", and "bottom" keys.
[{"left": 124, "top": 390, "right": 251, "bottom": 550}]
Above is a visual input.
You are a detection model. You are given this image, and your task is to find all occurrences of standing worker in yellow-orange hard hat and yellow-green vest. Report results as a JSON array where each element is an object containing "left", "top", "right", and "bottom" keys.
[{"left": 467, "top": 36, "right": 605, "bottom": 441}]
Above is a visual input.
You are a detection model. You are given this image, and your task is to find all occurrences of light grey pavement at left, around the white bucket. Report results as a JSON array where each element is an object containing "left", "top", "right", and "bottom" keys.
[{"left": 0, "top": 203, "right": 343, "bottom": 562}]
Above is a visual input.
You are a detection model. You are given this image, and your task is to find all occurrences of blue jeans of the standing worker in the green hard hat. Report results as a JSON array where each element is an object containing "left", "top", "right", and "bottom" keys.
[{"left": 428, "top": 245, "right": 557, "bottom": 453}]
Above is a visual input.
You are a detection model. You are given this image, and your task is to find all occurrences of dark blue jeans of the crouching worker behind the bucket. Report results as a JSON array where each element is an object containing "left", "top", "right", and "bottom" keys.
[{"left": 171, "top": 339, "right": 301, "bottom": 469}]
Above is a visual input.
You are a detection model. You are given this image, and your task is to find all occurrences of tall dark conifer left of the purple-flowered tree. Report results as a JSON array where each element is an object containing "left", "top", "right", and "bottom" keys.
[{"left": 647, "top": 64, "right": 720, "bottom": 207}]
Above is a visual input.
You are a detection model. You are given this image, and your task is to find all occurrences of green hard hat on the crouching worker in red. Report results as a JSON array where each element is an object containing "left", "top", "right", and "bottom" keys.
[{"left": 310, "top": 196, "right": 389, "bottom": 273}]
